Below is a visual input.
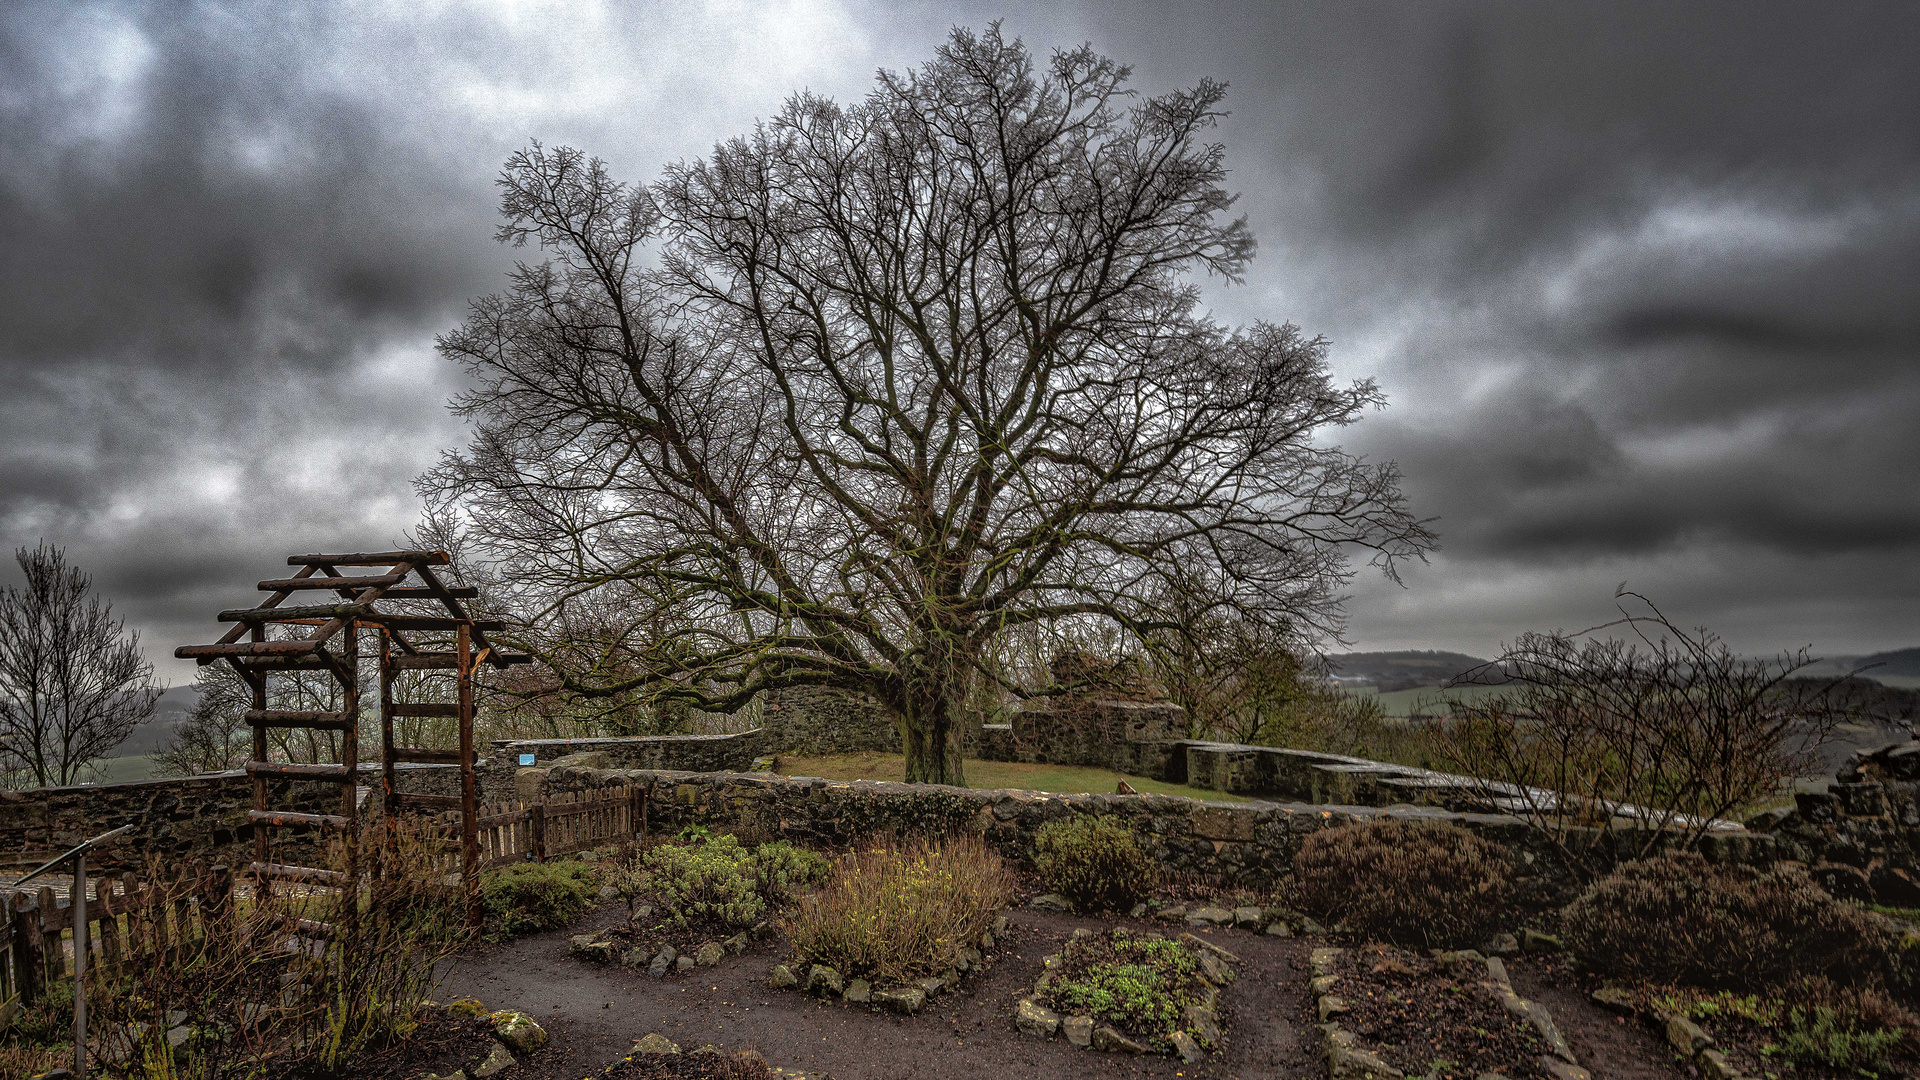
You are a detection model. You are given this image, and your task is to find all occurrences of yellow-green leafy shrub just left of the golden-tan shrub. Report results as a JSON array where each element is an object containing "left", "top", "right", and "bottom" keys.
[{"left": 637, "top": 832, "right": 828, "bottom": 926}]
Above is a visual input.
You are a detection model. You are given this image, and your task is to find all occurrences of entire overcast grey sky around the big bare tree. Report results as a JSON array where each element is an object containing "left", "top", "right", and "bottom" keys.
[{"left": 0, "top": 0, "right": 1920, "bottom": 680}]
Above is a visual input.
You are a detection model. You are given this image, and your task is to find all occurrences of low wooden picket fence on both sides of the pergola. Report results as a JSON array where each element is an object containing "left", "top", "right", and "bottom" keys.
[{"left": 0, "top": 788, "right": 647, "bottom": 999}]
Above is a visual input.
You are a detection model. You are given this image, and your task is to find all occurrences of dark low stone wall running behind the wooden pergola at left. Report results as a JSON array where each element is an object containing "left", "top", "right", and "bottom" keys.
[{"left": 0, "top": 765, "right": 461, "bottom": 871}]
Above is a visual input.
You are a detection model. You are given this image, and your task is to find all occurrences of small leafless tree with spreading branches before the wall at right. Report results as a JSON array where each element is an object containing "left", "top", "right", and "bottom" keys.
[{"left": 1434, "top": 588, "right": 1845, "bottom": 867}]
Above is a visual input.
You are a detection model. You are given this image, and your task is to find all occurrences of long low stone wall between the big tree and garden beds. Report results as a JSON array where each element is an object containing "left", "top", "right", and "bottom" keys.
[{"left": 530, "top": 767, "right": 1778, "bottom": 888}]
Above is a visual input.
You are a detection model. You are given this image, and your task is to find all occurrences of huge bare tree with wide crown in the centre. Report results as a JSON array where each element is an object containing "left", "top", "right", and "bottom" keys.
[{"left": 422, "top": 27, "right": 1430, "bottom": 782}]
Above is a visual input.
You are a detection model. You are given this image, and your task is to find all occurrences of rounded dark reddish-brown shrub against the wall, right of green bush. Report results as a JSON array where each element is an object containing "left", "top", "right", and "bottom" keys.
[{"left": 1294, "top": 819, "right": 1513, "bottom": 947}]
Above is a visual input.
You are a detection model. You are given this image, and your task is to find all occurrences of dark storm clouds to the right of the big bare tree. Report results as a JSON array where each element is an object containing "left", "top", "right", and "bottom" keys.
[{"left": 1052, "top": 2, "right": 1920, "bottom": 648}]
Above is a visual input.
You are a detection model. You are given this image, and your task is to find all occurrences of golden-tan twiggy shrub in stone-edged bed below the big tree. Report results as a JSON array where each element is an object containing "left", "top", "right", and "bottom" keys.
[{"left": 785, "top": 836, "right": 1014, "bottom": 982}]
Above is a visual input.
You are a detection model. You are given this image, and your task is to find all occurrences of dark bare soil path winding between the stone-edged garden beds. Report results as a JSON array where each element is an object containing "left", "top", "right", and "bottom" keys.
[{"left": 432, "top": 905, "right": 1320, "bottom": 1080}]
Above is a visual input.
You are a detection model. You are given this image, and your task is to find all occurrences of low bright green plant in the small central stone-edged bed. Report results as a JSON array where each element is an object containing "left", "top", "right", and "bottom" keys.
[{"left": 1046, "top": 930, "right": 1204, "bottom": 1049}]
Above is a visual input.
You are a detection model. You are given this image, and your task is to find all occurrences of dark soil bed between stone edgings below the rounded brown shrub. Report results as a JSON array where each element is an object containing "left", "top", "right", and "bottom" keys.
[{"left": 1332, "top": 945, "right": 1578, "bottom": 1080}]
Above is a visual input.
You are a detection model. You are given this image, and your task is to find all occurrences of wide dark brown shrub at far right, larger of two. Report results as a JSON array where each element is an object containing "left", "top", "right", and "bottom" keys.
[{"left": 1563, "top": 851, "right": 1895, "bottom": 992}]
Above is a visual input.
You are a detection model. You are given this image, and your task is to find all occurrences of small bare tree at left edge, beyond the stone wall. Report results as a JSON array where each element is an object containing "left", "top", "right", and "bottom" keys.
[{"left": 0, "top": 542, "right": 161, "bottom": 788}]
